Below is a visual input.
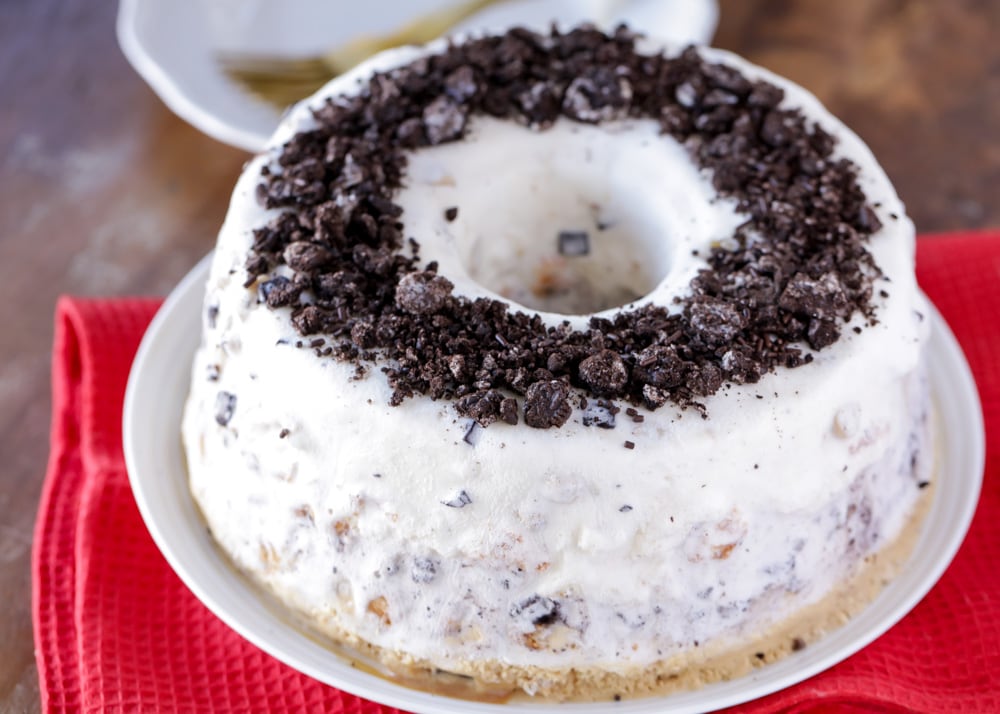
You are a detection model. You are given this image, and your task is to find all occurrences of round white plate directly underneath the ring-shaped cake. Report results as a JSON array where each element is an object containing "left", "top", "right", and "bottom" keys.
[{"left": 124, "top": 258, "right": 985, "bottom": 714}]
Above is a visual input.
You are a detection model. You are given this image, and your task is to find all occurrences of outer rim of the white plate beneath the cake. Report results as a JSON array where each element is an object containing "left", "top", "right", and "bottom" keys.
[{"left": 122, "top": 253, "right": 985, "bottom": 714}]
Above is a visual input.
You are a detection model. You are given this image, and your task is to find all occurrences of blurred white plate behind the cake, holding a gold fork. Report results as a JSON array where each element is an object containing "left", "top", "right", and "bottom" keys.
[{"left": 117, "top": 0, "right": 718, "bottom": 152}]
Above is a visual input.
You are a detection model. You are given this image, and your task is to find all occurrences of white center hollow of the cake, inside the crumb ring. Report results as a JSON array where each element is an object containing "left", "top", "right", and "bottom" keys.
[{"left": 400, "top": 118, "right": 732, "bottom": 316}]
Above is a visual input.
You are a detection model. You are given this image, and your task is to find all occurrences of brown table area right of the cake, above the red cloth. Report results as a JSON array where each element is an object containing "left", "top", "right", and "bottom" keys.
[{"left": 716, "top": 0, "right": 1000, "bottom": 233}]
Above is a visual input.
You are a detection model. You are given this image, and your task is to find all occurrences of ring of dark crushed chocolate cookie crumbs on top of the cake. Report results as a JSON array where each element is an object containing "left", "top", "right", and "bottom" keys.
[{"left": 250, "top": 28, "right": 880, "bottom": 428}]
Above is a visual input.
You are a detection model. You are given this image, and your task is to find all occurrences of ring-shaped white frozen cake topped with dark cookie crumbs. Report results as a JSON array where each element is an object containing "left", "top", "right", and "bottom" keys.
[{"left": 183, "top": 28, "right": 932, "bottom": 699}]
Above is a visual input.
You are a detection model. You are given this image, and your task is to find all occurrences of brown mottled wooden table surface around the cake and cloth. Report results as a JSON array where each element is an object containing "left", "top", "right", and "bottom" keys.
[{"left": 0, "top": 0, "right": 1000, "bottom": 711}]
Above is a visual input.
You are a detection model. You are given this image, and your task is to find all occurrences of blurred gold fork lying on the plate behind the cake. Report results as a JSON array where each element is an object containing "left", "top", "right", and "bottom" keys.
[{"left": 217, "top": 0, "right": 516, "bottom": 109}]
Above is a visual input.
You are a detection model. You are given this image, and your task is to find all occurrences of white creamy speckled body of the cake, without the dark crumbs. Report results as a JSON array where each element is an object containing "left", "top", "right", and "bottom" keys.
[{"left": 183, "top": 36, "right": 930, "bottom": 670}]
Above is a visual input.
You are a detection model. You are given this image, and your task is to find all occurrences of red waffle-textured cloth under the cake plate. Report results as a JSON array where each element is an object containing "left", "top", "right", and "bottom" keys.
[{"left": 32, "top": 232, "right": 1000, "bottom": 714}]
